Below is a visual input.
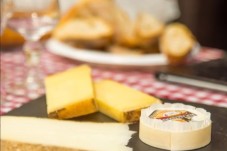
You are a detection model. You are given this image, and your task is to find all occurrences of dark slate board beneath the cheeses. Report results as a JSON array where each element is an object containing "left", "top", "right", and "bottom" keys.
[{"left": 6, "top": 95, "right": 227, "bottom": 151}]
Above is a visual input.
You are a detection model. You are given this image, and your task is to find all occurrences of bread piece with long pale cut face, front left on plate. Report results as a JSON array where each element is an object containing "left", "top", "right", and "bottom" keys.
[{"left": 53, "top": 17, "right": 113, "bottom": 48}]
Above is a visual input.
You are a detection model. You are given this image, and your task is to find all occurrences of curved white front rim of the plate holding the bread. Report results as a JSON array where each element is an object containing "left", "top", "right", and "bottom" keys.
[{"left": 46, "top": 39, "right": 167, "bottom": 66}]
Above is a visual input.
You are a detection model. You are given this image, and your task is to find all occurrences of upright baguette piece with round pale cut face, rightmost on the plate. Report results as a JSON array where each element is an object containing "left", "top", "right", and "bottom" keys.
[{"left": 160, "top": 23, "right": 196, "bottom": 65}]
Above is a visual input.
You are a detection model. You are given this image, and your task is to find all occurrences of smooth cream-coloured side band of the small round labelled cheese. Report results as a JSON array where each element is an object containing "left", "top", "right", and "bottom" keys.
[{"left": 139, "top": 121, "right": 211, "bottom": 151}]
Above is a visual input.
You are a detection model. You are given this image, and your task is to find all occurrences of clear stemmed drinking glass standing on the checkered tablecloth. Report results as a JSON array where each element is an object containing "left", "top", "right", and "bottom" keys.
[{"left": 7, "top": 0, "right": 60, "bottom": 98}]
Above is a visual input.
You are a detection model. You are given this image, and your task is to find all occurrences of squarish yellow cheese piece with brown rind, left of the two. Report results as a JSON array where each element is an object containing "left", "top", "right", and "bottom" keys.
[{"left": 45, "top": 65, "right": 97, "bottom": 119}]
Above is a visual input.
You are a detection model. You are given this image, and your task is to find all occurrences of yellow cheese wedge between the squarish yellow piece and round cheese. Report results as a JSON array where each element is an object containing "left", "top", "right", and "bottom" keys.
[{"left": 95, "top": 80, "right": 160, "bottom": 122}]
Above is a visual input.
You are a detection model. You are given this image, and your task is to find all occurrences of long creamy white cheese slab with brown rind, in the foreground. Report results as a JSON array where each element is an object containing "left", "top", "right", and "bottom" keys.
[{"left": 0, "top": 116, "right": 134, "bottom": 151}]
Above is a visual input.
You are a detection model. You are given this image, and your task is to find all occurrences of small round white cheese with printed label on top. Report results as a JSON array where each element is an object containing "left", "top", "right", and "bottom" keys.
[{"left": 139, "top": 103, "right": 211, "bottom": 150}]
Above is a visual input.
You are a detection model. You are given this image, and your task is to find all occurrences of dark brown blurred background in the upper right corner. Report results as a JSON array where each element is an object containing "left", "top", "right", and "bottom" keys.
[{"left": 177, "top": 0, "right": 227, "bottom": 51}]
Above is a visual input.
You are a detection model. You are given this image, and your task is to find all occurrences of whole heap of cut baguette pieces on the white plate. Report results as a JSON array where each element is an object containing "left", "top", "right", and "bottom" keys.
[{"left": 53, "top": 0, "right": 196, "bottom": 58}]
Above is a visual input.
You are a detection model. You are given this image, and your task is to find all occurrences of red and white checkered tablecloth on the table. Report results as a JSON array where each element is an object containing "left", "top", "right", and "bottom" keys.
[{"left": 0, "top": 48, "right": 227, "bottom": 115}]
